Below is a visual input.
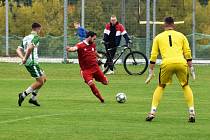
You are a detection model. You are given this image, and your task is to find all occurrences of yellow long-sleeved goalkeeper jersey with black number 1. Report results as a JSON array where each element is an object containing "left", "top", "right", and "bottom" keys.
[{"left": 150, "top": 30, "right": 192, "bottom": 65}]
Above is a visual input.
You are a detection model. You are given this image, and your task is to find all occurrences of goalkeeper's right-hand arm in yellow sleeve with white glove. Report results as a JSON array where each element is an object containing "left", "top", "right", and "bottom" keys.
[{"left": 183, "top": 36, "right": 195, "bottom": 80}]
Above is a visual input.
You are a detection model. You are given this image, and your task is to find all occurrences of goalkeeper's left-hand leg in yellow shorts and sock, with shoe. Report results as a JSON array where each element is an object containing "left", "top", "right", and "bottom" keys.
[{"left": 146, "top": 66, "right": 173, "bottom": 121}]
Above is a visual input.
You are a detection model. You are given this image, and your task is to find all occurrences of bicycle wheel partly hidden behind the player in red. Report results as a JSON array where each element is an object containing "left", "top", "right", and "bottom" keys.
[{"left": 98, "top": 51, "right": 110, "bottom": 74}]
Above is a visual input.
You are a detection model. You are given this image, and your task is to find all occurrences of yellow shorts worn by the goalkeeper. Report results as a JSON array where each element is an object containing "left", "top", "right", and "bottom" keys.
[{"left": 159, "top": 63, "right": 189, "bottom": 86}]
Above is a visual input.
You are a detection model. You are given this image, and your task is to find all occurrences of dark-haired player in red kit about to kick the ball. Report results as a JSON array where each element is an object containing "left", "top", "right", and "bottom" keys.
[{"left": 66, "top": 31, "right": 108, "bottom": 103}]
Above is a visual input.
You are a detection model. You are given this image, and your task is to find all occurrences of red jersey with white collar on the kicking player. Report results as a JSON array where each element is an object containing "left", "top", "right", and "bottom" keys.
[{"left": 76, "top": 40, "right": 98, "bottom": 71}]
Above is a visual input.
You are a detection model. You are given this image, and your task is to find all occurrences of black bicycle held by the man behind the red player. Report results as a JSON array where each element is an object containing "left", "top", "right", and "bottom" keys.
[{"left": 98, "top": 43, "right": 148, "bottom": 75}]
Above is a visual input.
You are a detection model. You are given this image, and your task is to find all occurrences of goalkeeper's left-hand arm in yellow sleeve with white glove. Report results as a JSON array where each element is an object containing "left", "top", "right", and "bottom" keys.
[{"left": 145, "top": 38, "right": 159, "bottom": 84}]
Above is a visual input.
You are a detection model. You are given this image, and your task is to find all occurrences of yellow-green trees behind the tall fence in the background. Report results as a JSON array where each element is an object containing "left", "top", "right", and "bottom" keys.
[{"left": 0, "top": 0, "right": 210, "bottom": 37}]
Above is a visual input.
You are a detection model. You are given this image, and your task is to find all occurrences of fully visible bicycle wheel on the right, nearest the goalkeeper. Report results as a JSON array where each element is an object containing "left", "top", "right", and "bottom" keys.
[{"left": 124, "top": 51, "right": 148, "bottom": 75}]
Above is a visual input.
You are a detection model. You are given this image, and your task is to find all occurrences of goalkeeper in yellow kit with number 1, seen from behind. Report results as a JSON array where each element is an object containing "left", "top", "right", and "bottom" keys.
[{"left": 145, "top": 17, "right": 195, "bottom": 122}]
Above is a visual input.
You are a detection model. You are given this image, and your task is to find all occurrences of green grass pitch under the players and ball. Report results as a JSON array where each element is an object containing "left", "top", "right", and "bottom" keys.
[{"left": 0, "top": 63, "right": 210, "bottom": 140}]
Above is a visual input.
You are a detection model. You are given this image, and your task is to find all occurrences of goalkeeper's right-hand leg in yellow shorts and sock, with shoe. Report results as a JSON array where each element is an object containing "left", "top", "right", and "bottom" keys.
[{"left": 176, "top": 64, "right": 195, "bottom": 122}]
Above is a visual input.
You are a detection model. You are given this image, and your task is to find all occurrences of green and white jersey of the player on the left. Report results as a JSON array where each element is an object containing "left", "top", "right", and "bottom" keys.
[{"left": 19, "top": 31, "right": 40, "bottom": 66}]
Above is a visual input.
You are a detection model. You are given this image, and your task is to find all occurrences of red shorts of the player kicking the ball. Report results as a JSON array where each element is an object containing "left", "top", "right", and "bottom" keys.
[{"left": 81, "top": 67, "right": 108, "bottom": 84}]
